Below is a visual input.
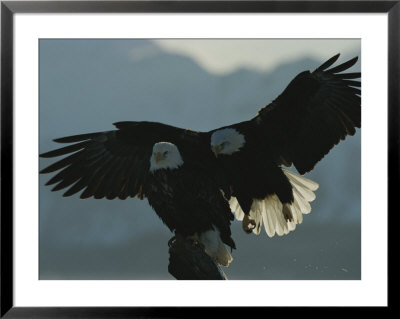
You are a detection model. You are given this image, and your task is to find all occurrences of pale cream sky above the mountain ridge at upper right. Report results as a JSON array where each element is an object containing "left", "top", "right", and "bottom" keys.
[{"left": 153, "top": 39, "right": 360, "bottom": 74}]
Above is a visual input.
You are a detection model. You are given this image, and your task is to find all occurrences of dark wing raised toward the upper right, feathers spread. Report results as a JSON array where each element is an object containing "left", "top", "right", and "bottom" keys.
[{"left": 245, "top": 54, "right": 361, "bottom": 174}]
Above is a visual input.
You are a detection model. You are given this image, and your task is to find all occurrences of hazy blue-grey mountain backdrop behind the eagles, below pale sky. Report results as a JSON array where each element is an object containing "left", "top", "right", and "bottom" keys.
[{"left": 39, "top": 40, "right": 361, "bottom": 279}]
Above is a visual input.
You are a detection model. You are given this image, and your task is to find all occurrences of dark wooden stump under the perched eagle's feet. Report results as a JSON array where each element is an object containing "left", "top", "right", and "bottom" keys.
[{"left": 168, "top": 235, "right": 227, "bottom": 280}]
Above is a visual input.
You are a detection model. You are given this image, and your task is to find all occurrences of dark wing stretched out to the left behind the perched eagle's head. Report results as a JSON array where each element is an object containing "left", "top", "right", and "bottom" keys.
[{"left": 40, "top": 122, "right": 212, "bottom": 199}]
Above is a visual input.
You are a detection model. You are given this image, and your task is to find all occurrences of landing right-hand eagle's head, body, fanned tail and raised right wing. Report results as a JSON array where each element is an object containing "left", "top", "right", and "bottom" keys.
[{"left": 210, "top": 54, "right": 361, "bottom": 237}]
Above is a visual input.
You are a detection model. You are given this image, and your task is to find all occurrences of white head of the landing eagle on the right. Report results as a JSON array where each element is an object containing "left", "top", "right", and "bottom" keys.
[{"left": 211, "top": 128, "right": 245, "bottom": 157}]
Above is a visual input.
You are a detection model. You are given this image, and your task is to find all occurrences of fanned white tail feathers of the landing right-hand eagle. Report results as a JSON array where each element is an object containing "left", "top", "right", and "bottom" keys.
[{"left": 229, "top": 169, "right": 318, "bottom": 237}]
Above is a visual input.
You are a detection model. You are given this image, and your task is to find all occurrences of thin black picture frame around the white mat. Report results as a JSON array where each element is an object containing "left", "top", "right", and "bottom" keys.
[{"left": 0, "top": 0, "right": 394, "bottom": 318}]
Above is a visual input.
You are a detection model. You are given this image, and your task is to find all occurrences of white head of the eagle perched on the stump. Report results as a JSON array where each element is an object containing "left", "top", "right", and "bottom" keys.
[{"left": 150, "top": 142, "right": 183, "bottom": 172}]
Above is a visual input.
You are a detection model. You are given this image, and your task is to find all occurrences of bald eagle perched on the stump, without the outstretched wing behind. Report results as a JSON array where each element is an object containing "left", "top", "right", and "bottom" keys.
[{"left": 143, "top": 142, "right": 235, "bottom": 266}]
